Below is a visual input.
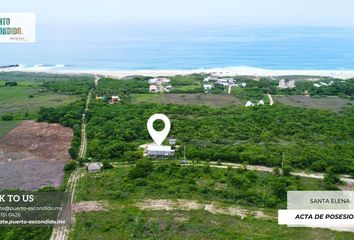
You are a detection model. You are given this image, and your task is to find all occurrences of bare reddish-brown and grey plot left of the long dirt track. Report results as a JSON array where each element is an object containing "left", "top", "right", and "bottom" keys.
[{"left": 0, "top": 121, "right": 73, "bottom": 190}]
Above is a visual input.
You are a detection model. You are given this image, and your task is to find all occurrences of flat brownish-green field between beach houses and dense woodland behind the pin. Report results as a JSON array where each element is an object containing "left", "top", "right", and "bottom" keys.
[{"left": 131, "top": 93, "right": 243, "bottom": 107}]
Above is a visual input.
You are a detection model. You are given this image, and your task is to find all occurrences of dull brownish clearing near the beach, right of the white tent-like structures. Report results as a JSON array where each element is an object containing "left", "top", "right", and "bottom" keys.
[{"left": 273, "top": 96, "right": 354, "bottom": 112}]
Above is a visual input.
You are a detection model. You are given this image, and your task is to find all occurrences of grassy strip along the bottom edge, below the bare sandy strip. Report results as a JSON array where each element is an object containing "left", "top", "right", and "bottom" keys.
[{"left": 71, "top": 208, "right": 353, "bottom": 240}]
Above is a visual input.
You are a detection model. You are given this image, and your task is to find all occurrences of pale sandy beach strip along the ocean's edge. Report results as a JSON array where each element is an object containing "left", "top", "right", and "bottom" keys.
[{"left": 0, "top": 67, "right": 354, "bottom": 79}]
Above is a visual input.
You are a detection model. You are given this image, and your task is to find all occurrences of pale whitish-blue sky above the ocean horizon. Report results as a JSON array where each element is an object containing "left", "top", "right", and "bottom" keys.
[{"left": 0, "top": 0, "right": 354, "bottom": 27}]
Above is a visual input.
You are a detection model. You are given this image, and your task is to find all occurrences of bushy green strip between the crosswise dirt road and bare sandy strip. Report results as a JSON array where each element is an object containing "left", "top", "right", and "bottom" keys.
[{"left": 76, "top": 160, "right": 325, "bottom": 208}]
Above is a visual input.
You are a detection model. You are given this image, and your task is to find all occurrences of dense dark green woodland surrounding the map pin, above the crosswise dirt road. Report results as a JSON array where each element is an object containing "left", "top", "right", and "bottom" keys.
[{"left": 87, "top": 102, "right": 354, "bottom": 173}]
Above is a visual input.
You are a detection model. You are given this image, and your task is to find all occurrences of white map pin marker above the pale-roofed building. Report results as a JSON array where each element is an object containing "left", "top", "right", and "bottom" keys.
[{"left": 147, "top": 113, "right": 171, "bottom": 145}]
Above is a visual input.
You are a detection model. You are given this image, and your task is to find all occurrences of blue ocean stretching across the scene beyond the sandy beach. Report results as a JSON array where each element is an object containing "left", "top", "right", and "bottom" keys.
[{"left": 0, "top": 24, "right": 354, "bottom": 70}]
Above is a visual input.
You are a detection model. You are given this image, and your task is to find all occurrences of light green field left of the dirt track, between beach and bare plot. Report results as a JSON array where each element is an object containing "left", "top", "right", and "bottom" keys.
[{"left": 0, "top": 73, "right": 92, "bottom": 120}]
